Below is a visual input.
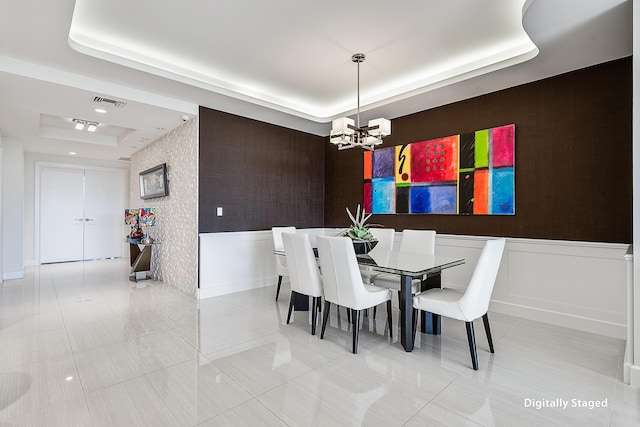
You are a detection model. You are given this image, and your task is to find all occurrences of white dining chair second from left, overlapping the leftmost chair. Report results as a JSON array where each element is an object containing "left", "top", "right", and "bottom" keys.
[{"left": 282, "top": 233, "right": 322, "bottom": 335}]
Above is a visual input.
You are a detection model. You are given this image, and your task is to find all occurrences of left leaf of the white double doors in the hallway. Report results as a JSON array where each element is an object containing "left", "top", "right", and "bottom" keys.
[{"left": 40, "top": 168, "right": 84, "bottom": 263}]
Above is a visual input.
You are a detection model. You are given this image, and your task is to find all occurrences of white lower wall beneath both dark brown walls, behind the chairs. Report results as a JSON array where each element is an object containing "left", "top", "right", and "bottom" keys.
[{"left": 200, "top": 229, "right": 627, "bottom": 339}]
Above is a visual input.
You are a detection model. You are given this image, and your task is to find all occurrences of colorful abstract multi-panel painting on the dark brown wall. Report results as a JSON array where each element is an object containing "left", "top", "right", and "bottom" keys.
[{"left": 364, "top": 124, "right": 515, "bottom": 215}]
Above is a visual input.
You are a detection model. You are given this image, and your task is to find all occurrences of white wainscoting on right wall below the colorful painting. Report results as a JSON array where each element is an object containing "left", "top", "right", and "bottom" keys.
[{"left": 436, "top": 235, "right": 628, "bottom": 339}]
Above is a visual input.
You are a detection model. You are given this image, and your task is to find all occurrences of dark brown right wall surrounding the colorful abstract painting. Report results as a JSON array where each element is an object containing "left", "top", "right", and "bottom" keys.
[{"left": 325, "top": 58, "right": 632, "bottom": 243}]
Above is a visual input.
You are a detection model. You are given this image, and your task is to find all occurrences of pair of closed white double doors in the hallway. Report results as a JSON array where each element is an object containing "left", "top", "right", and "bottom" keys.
[{"left": 40, "top": 167, "right": 125, "bottom": 263}]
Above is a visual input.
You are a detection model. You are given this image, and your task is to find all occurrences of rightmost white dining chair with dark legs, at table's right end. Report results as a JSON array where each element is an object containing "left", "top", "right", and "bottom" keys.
[{"left": 413, "top": 238, "right": 506, "bottom": 371}]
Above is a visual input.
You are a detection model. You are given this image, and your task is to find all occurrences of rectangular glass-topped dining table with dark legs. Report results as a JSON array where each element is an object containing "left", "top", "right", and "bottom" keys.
[{"left": 356, "top": 248, "right": 465, "bottom": 351}]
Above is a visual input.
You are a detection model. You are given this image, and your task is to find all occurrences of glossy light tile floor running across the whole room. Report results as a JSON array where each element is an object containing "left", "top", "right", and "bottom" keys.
[{"left": 0, "top": 260, "right": 640, "bottom": 427}]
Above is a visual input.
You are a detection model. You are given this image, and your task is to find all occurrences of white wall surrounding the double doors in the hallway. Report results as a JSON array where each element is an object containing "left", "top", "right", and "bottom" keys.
[{"left": 23, "top": 153, "right": 129, "bottom": 266}]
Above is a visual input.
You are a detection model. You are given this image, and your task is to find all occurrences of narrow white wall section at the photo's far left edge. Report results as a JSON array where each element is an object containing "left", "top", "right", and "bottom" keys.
[{"left": 2, "top": 137, "right": 24, "bottom": 280}]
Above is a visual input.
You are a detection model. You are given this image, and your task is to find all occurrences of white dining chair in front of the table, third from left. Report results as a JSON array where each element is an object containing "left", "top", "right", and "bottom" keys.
[{"left": 317, "top": 236, "right": 393, "bottom": 354}]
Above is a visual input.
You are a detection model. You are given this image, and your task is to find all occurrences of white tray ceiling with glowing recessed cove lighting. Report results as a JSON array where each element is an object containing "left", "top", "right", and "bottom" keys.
[{"left": 0, "top": 0, "right": 632, "bottom": 160}]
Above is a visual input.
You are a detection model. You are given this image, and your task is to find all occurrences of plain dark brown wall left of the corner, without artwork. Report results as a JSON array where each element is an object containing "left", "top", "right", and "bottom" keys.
[{"left": 198, "top": 107, "right": 325, "bottom": 233}]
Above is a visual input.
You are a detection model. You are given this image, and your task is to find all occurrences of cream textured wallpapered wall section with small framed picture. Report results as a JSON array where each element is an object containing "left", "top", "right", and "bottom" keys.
[{"left": 129, "top": 118, "right": 198, "bottom": 296}]
